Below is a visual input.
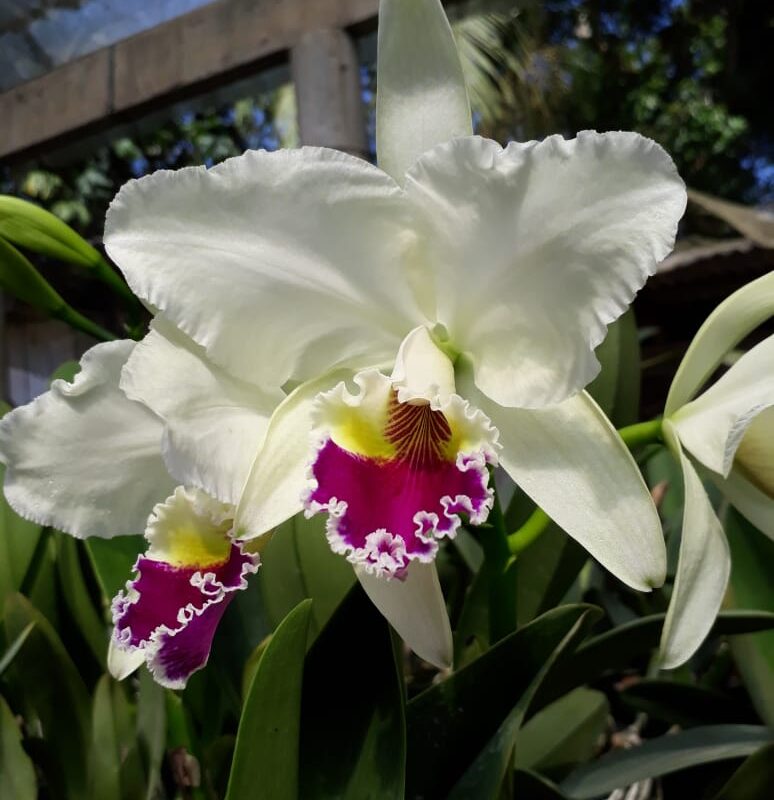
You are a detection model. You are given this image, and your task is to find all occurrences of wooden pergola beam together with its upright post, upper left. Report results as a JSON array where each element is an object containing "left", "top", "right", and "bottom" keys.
[{"left": 0, "top": 0, "right": 394, "bottom": 160}]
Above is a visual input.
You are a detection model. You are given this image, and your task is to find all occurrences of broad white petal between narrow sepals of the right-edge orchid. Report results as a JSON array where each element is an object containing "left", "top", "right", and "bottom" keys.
[{"left": 671, "top": 336, "right": 774, "bottom": 478}]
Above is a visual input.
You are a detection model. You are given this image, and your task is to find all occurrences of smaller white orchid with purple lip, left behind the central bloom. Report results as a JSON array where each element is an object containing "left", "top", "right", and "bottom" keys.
[{"left": 0, "top": 338, "right": 282, "bottom": 688}]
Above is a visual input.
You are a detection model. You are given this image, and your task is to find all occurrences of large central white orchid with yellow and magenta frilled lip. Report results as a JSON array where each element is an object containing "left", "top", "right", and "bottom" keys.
[{"left": 100, "top": 0, "right": 685, "bottom": 666}]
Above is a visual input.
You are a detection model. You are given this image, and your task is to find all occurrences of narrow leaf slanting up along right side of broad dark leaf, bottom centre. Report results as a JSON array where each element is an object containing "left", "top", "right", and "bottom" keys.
[{"left": 449, "top": 607, "right": 597, "bottom": 800}]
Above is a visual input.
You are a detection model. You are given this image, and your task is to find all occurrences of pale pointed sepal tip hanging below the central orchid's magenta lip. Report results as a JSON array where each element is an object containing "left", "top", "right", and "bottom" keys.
[{"left": 355, "top": 561, "right": 454, "bottom": 669}]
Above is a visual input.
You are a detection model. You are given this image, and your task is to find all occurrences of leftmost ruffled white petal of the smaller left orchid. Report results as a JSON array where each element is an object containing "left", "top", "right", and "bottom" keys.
[{"left": 0, "top": 341, "right": 174, "bottom": 538}]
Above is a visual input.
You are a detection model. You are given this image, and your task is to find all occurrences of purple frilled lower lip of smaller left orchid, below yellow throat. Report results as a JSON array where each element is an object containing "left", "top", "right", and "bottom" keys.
[{"left": 111, "top": 542, "right": 261, "bottom": 689}]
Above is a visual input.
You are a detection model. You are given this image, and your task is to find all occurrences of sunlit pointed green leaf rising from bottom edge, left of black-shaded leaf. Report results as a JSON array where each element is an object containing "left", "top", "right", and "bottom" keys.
[{"left": 226, "top": 600, "right": 312, "bottom": 800}]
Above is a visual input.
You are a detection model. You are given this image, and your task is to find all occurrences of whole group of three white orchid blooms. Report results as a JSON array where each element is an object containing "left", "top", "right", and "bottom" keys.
[{"left": 0, "top": 0, "right": 774, "bottom": 688}]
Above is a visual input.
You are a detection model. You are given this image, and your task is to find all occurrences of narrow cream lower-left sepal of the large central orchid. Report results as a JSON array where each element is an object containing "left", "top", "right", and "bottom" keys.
[{"left": 234, "top": 370, "right": 350, "bottom": 540}]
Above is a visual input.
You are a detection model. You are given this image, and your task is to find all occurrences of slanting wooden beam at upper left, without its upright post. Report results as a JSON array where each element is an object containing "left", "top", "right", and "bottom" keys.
[{"left": 0, "top": 0, "right": 379, "bottom": 159}]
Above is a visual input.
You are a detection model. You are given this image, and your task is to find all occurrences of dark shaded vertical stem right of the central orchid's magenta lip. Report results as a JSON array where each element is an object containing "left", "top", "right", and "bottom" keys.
[{"left": 480, "top": 492, "right": 516, "bottom": 644}]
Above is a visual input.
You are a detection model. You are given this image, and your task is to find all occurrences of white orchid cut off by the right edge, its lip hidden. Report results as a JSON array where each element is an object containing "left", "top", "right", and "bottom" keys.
[{"left": 661, "top": 273, "right": 774, "bottom": 669}]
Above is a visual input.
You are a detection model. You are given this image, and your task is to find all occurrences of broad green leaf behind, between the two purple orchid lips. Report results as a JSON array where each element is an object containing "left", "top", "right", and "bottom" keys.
[{"left": 258, "top": 514, "right": 355, "bottom": 634}]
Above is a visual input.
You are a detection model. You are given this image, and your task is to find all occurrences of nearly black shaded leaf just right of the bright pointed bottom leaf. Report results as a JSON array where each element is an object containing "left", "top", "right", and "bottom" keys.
[{"left": 299, "top": 585, "right": 406, "bottom": 800}]
